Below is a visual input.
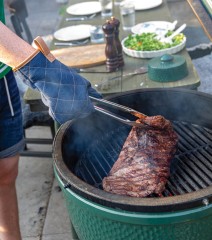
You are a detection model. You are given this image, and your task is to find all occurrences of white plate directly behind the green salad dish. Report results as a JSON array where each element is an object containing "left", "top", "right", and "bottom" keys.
[{"left": 131, "top": 21, "right": 175, "bottom": 34}]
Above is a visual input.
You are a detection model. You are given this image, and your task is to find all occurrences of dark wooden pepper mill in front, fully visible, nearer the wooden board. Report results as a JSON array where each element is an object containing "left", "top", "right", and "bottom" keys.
[{"left": 102, "top": 20, "right": 118, "bottom": 72}]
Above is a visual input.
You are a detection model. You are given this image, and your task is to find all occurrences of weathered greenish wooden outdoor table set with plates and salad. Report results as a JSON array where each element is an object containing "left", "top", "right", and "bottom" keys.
[{"left": 24, "top": 0, "right": 200, "bottom": 111}]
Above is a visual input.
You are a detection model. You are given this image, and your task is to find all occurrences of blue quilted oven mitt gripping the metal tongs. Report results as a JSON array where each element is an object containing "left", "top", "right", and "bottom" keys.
[{"left": 14, "top": 37, "right": 101, "bottom": 124}]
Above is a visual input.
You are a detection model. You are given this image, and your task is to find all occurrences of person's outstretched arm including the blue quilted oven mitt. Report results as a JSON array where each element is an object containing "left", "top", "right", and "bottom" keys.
[{"left": 0, "top": 22, "right": 101, "bottom": 124}]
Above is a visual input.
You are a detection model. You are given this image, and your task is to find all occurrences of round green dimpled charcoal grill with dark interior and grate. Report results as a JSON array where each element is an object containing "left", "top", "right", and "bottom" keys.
[{"left": 53, "top": 89, "right": 212, "bottom": 240}]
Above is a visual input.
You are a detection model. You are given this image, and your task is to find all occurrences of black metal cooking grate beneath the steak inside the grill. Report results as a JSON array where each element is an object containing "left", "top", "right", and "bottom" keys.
[{"left": 74, "top": 121, "right": 212, "bottom": 197}]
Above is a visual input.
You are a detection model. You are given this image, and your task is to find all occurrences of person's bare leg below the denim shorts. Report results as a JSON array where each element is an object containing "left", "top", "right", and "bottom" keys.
[{"left": 0, "top": 155, "right": 21, "bottom": 240}]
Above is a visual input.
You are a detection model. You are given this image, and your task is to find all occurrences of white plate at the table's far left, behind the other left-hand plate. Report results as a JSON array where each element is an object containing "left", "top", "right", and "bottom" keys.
[{"left": 66, "top": 2, "right": 102, "bottom": 15}]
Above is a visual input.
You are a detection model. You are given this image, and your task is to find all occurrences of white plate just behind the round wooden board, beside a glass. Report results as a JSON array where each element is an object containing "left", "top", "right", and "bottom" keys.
[{"left": 54, "top": 24, "right": 91, "bottom": 41}]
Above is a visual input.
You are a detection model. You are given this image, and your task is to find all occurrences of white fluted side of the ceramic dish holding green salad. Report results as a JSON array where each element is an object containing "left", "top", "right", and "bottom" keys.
[{"left": 121, "top": 37, "right": 186, "bottom": 58}]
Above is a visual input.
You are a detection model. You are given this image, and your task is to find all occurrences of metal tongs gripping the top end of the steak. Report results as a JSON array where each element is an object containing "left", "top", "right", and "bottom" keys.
[{"left": 89, "top": 96, "right": 149, "bottom": 128}]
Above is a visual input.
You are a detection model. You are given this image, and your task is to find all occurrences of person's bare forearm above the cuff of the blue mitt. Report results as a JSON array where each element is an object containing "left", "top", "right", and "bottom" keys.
[{"left": 0, "top": 22, "right": 37, "bottom": 68}]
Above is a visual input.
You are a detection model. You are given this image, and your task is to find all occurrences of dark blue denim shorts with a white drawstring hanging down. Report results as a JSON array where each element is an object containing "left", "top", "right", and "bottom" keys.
[{"left": 0, "top": 71, "right": 25, "bottom": 159}]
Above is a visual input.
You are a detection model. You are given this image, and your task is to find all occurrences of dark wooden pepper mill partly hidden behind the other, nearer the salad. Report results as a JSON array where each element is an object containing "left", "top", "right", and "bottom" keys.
[{"left": 110, "top": 17, "right": 124, "bottom": 67}]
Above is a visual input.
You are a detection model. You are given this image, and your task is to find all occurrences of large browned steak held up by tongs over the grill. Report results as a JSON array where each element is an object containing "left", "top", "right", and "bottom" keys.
[{"left": 102, "top": 116, "right": 178, "bottom": 197}]
